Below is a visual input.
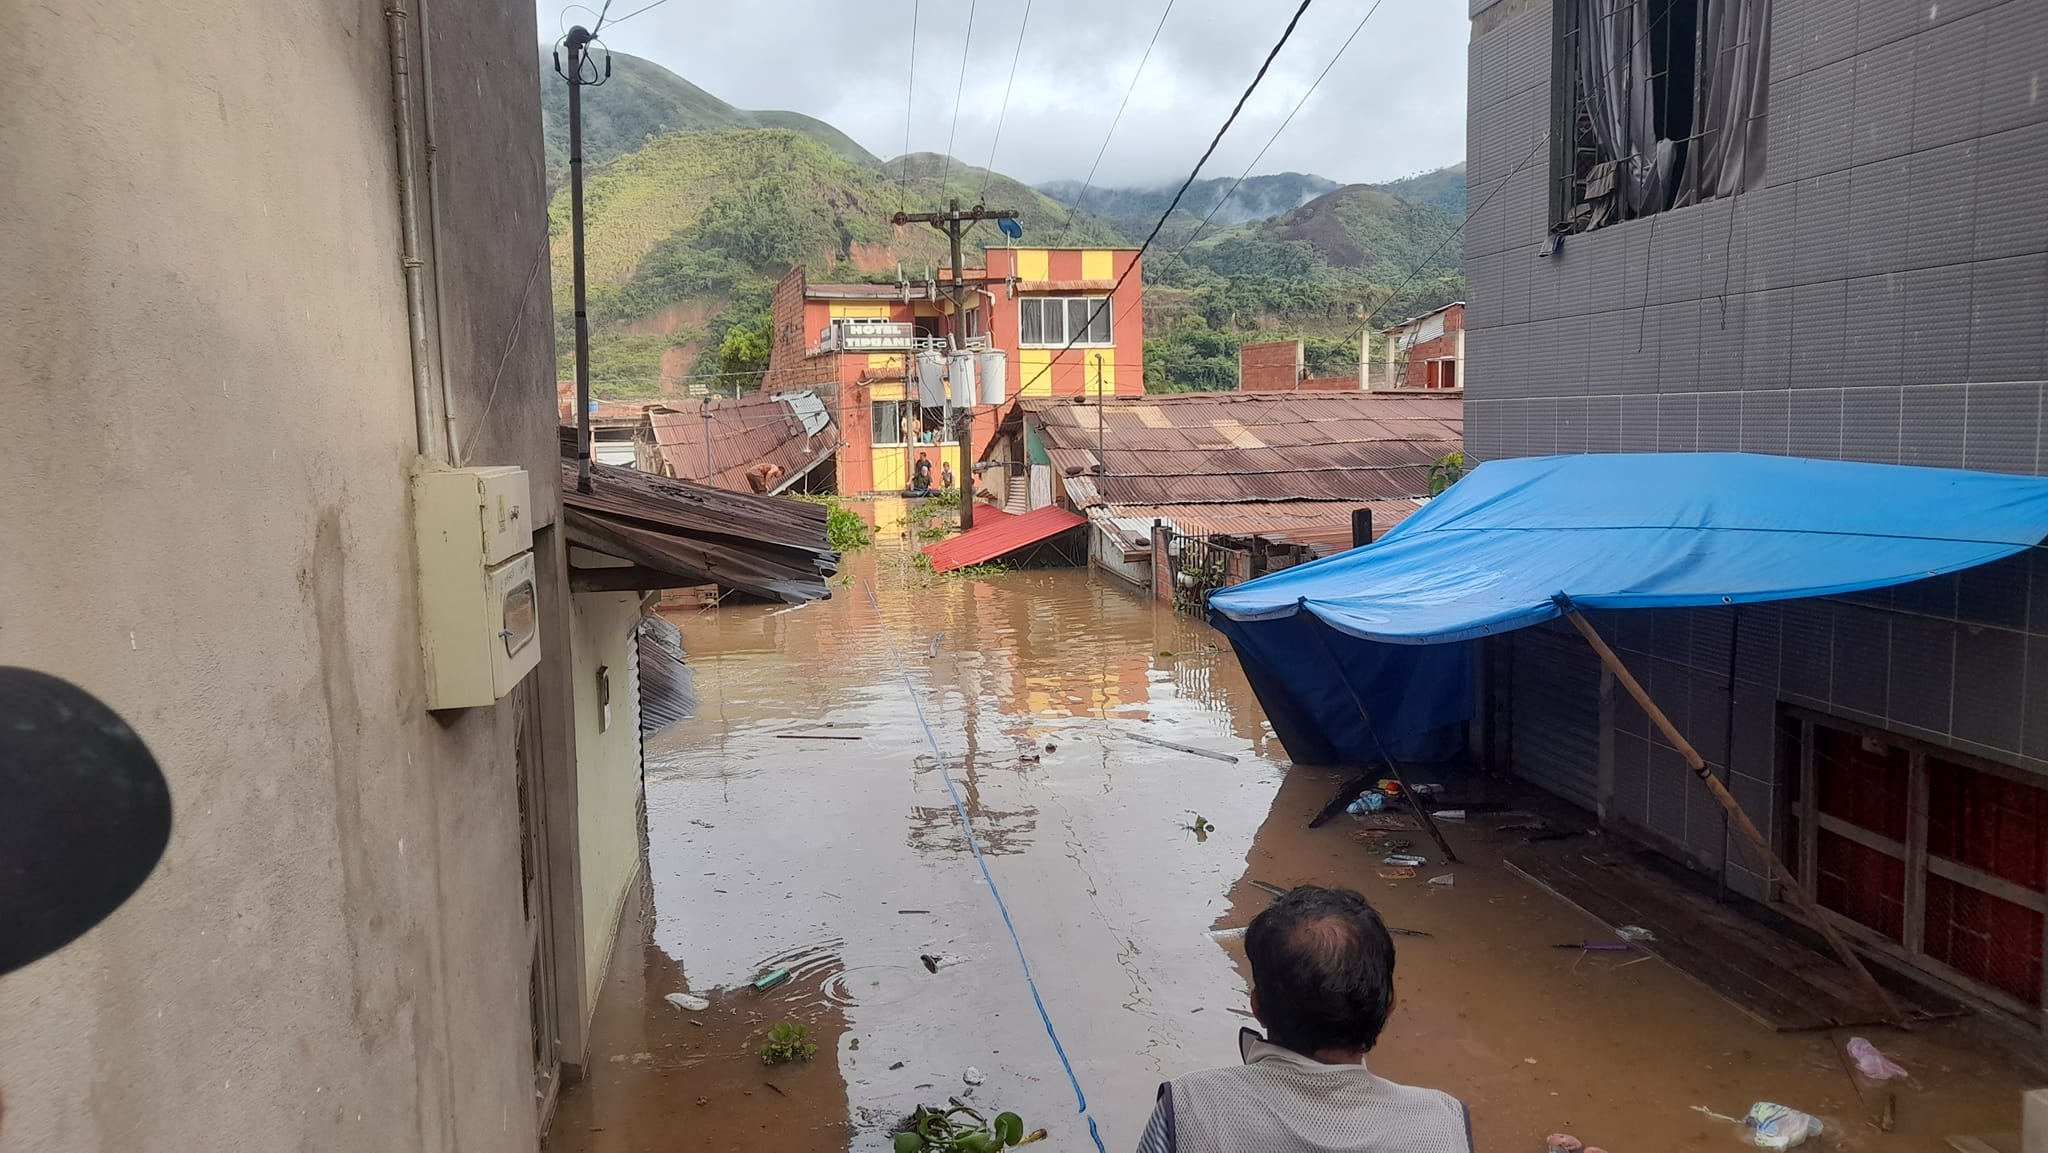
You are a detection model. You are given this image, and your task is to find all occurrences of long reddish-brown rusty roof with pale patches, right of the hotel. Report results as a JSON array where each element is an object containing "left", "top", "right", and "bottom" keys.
[{"left": 1030, "top": 393, "right": 1464, "bottom": 505}]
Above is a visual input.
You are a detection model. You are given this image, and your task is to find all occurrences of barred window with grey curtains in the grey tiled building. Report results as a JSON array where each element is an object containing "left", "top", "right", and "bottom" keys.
[{"left": 1550, "top": 0, "right": 1774, "bottom": 231}]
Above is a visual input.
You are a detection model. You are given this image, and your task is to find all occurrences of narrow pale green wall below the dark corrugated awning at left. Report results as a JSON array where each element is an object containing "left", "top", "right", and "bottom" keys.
[{"left": 569, "top": 573, "right": 641, "bottom": 1003}]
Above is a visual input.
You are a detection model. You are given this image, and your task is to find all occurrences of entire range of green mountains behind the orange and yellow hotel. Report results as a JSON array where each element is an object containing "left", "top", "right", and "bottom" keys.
[{"left": 541, "top": 51, "right": 1464, "bottom": 397}]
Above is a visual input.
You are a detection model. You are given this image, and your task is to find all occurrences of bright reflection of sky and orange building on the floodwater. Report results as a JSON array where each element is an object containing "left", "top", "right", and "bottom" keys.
[{"left": 630, "top": 544, "right": 1278, "bottom": 1145}]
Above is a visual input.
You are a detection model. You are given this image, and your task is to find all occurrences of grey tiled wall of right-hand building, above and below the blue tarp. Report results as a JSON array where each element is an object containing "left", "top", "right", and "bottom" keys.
[{"left": 1464, "top": 0, "right": 2048, "bottom": 901}]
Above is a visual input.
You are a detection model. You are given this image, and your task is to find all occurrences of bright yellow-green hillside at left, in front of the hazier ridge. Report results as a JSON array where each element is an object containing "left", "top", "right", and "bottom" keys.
[{"left": 549, "top": 129, "right": 1120, "bottom": 395}]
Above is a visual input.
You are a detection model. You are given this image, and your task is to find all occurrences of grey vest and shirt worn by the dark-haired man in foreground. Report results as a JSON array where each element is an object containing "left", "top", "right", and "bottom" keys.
[{"left": 1139, "top": 1028, "right": 1473, "bottom": 1153}]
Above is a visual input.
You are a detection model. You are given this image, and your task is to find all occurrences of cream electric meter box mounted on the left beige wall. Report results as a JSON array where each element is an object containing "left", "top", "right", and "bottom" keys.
[{"left": 412, "top": 467, "right": 541, "bottom": 709}]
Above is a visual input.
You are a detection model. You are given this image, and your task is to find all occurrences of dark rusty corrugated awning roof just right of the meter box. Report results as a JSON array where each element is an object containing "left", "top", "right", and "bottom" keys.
[{"left": 561, "top": 461, "right": 840, "bottom": 604}]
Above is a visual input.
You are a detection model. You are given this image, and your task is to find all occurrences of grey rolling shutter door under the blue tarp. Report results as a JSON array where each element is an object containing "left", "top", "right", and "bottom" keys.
[{"left": 1509, "top": 625, "right": 1599, "bottom": 809}]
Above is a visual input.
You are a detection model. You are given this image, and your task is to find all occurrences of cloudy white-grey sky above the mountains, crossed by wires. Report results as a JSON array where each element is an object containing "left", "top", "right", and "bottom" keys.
[{"left": 539, "top": 0, "right": 1466, "bottom": 186}]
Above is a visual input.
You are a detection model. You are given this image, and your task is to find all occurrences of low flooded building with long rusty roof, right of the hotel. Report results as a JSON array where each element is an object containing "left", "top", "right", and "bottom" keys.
[{"left": 983, "top": 391, "right": 1464, "bottom": 586}]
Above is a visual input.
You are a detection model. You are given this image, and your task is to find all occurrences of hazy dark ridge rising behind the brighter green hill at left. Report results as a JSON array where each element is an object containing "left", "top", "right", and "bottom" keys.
[{"left": 541, "top": 47, "right": 881, "bottom": 170}]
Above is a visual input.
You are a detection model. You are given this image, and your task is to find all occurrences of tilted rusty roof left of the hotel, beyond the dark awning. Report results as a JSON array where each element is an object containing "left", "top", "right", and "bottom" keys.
[{"left": 641, "top": 391, "right": 840, "bottom": 494}]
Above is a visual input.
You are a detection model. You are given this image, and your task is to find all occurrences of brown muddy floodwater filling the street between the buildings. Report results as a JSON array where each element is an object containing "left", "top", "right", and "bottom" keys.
[{"left": 547, "top": 508, "right": 2021, "bottom": 1153}]
